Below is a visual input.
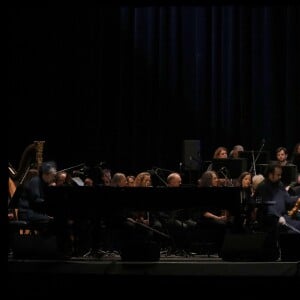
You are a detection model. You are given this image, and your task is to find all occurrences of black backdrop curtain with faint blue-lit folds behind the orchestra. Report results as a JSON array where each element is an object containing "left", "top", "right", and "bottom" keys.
[{"left": 7, "top": 5, "right": 300, "bottom": 176}]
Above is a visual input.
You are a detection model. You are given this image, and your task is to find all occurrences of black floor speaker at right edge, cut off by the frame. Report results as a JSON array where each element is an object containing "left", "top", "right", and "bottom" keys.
[{"left": 279, "top": 233, "right": 300, "bottom": 261}]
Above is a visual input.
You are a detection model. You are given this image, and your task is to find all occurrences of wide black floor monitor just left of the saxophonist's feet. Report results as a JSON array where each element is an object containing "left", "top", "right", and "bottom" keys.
[{"left": 221, "top": 232, "right": 279, "bottom": 261}]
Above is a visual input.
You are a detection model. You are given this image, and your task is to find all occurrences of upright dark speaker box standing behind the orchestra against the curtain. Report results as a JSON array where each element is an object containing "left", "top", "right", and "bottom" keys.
[{"left": 183, "top": 140, "right": 201, "bottom": 171}]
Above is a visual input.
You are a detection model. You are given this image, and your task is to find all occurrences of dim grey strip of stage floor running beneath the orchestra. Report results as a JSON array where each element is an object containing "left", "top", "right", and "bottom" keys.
[{"left": 8, "top": 254, "right": 300, "bottom": 277}]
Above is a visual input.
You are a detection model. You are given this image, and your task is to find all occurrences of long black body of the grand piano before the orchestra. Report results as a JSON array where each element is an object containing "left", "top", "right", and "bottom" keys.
[{"left": 45, "top": 186, "right": 242, "bottom": 217}]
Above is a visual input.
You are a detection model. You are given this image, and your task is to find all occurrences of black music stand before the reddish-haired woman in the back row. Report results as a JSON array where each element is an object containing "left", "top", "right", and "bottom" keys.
[{"left": 212, "top": 158, "right": 247, "bottom": 178}]
